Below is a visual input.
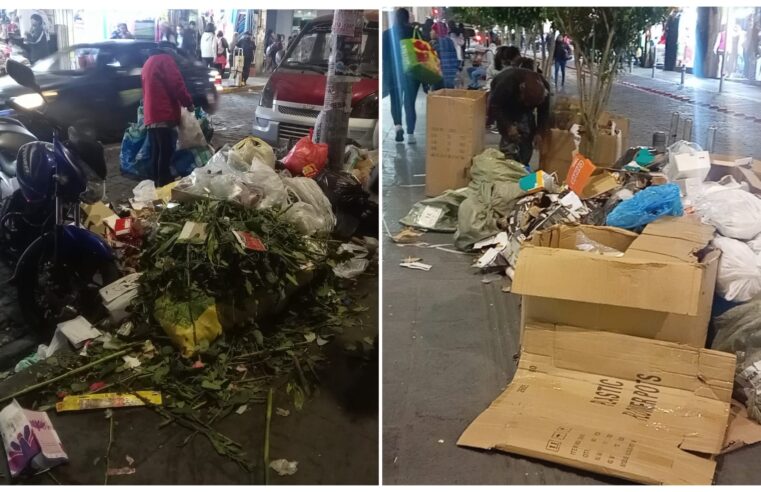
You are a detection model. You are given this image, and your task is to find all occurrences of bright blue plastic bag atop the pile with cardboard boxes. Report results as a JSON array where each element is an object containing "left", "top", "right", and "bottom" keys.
[{"left": 606, "top": 183, "right": 684, "bottom": 230}]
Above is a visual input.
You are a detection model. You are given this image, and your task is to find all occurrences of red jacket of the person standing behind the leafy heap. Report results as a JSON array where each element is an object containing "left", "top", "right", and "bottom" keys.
[{"left": 142, "top": 54, "right": 193, "bottom": 126}]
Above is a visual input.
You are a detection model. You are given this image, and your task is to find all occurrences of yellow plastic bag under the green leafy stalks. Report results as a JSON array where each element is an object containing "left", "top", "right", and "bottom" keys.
[{"left": 153, "top": 295, "right": 222, "bottom": 357}]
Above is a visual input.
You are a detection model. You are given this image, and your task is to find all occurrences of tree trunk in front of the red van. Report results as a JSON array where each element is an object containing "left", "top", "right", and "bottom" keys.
[{"left": 314, "top": 10, "right": 364, "bottom": 171}]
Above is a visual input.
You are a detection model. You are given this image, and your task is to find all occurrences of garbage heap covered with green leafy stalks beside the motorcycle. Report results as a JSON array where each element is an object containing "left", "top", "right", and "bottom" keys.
[{"left": 0, "top": 132, "right": 378, "bottom": 480}]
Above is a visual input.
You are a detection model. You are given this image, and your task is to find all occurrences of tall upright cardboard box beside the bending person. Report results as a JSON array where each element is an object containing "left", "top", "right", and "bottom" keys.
[{"left": 425, "top": 89, "right": 486, "bottom": 196}]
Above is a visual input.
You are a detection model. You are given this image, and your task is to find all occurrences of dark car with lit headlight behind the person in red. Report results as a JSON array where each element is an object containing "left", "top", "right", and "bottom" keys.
[{"left": 0, "top": 40, "right": 219, "bottom": 142}]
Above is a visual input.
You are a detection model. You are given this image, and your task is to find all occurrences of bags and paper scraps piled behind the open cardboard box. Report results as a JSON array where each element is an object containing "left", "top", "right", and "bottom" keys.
[{"left": 397, "top": 137, "right": 761, "bottom": 422}]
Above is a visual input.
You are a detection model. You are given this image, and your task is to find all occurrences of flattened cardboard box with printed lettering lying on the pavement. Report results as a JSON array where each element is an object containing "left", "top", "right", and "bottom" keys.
[{"left": 457, "top": 324, "right": 735, "bottom": 485}]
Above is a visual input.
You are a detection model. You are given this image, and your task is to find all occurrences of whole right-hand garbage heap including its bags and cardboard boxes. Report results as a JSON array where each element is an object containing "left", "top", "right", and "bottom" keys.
[{"left": 396, "top": 91, "right": 761, "bottom": 484}]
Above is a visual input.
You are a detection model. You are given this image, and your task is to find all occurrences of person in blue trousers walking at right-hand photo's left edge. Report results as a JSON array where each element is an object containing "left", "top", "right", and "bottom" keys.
[{"left": 383, "top": 8, "right": 418, "bottom": 144}]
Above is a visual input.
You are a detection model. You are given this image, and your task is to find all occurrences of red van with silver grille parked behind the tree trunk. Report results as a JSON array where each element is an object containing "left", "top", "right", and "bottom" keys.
[{"left": 253, "top": 15, "right": 379, "bottom": 148}]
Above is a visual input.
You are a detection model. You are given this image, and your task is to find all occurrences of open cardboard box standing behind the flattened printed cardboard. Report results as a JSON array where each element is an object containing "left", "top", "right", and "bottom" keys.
[{"left": 512, "top": 216, "right": 721, "bottom": 348}]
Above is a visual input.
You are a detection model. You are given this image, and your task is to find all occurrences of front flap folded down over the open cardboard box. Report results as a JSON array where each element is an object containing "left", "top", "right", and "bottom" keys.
[{"left": 513, "top": 244, "right": 702, "bottom": 316}]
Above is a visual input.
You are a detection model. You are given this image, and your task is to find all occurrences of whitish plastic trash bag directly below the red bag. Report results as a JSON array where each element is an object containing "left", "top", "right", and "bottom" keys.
[{"left": 283, "top": 177, "right": 336, "bottom": 236}]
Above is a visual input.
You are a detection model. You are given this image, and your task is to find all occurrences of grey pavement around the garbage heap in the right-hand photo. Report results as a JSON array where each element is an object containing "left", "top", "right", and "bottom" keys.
[{"left": 381, "top": 77, "right": 761, "bottom": 485}]
